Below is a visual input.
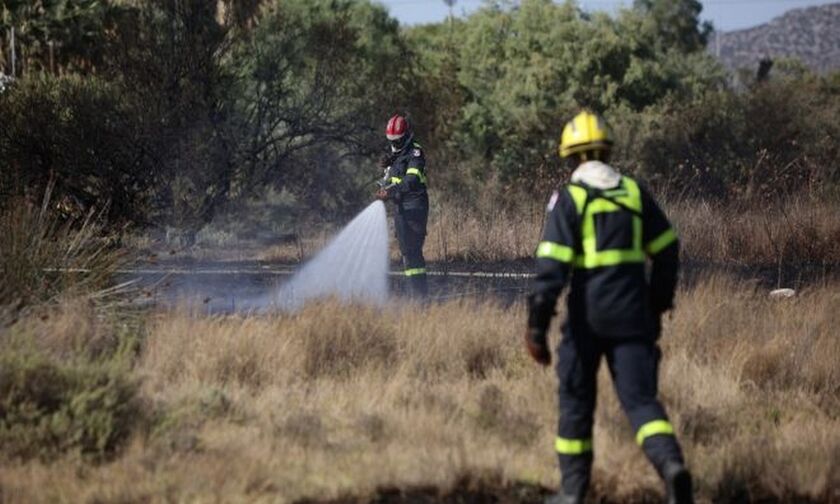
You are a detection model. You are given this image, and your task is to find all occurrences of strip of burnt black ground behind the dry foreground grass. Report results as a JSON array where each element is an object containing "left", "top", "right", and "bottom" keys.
[{"left": 117, "top": 259, "right": 840, "bottom": 313}]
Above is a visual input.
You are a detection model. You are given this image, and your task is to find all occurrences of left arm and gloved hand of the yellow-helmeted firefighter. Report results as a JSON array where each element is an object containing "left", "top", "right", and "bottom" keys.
[{"left": 525, "top": 190, "right": 577, "bottom": 365}]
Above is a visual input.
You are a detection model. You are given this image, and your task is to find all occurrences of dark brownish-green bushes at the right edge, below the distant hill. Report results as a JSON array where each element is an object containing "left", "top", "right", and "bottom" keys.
[{"left": 618, "top": 76, "right": 840, "bottom": 200}]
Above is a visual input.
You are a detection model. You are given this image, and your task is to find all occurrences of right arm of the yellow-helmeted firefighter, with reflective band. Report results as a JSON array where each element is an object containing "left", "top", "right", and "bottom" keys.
[{"left": 642, "top": 188, "right": 680, "bottom": 316}]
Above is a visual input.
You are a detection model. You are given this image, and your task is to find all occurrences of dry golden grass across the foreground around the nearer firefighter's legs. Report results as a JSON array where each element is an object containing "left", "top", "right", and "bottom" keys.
[{"left": 0, "top": 278, "right": 840, "bottom": 502}]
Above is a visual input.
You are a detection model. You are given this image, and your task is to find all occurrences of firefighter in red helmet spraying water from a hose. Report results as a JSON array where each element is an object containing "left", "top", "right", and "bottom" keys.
[{"left": 376, "top": 114, "right": 429, "bottom": 297}]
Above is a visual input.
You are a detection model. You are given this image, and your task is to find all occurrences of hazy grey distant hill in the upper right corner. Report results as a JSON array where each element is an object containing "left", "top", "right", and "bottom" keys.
[{"left": 709, "top": 3, "right": 840, "bottom": 72}]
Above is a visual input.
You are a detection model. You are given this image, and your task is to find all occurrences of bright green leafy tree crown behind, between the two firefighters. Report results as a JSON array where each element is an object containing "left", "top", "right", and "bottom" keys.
[{"left": 416, "top": 0, "right": 723, "bottom": 188}]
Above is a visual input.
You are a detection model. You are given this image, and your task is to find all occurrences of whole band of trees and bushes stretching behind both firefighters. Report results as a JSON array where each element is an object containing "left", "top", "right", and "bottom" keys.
[{"left": 0, "top": 0, "right": 837, "bottom": 225}]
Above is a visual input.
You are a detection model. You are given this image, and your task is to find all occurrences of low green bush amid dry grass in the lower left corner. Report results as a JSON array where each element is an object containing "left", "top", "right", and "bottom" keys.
[{"left": 0, "top": 348, "right": 141, "bottom": 460}]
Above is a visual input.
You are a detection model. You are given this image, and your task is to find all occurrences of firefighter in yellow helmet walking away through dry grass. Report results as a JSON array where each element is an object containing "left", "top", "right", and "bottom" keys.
[{"left": 525, "top": 111, "right": 693, "bottom": 504}]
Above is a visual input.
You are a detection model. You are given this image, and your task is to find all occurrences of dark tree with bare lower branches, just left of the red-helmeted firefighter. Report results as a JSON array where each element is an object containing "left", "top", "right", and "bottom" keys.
[{"left": 230, "top": 0, "right": 412, "bottom": 216}]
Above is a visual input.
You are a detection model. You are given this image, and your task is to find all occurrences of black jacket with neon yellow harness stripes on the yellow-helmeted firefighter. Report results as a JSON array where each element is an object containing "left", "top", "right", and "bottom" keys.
[{"left": 531, "top": 165, "right": 679, "bottom": 338}]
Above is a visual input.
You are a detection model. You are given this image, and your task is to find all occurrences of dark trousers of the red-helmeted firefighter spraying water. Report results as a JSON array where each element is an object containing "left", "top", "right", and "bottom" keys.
[{"left": 394, "top": 208, "right": 429, "bottom": 297}]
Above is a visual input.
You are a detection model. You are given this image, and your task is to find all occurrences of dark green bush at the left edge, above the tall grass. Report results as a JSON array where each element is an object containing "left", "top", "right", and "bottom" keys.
[{"left": 0, "top": 75, "right": 148, "bottom": 221}]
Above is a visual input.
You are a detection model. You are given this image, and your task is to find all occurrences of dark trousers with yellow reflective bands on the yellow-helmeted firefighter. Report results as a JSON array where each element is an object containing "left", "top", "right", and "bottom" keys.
[{"left": 555, "top": 324, "right": 683, "bottom": 496}]
